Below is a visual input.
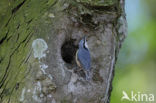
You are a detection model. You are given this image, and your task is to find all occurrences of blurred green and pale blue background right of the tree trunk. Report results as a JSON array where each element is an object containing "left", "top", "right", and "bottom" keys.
[{"left": 110, "top": 0, "right": 156, "bottom": 103}]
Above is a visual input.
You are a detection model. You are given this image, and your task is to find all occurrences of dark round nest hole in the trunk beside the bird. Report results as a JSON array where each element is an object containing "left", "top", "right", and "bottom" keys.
[{"left": 61, "top": 39, "right": 78, "bottom": 64}]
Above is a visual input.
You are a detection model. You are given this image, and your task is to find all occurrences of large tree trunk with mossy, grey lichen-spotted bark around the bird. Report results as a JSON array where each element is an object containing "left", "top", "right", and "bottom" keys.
[{"left": 0, "top": 0, "right": 127, "bottom": 103}]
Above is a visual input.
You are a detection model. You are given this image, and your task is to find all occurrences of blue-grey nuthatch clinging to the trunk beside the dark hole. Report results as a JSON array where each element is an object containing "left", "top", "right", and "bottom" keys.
[{"left": 76, "top": 37, "right": 91, "bottom": 80}]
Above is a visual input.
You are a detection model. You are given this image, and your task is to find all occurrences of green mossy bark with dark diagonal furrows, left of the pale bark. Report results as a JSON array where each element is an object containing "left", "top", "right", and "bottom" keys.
[{"left": 0, "top": 0, "right": 54, "bottom": 103}]
